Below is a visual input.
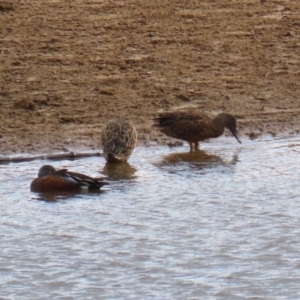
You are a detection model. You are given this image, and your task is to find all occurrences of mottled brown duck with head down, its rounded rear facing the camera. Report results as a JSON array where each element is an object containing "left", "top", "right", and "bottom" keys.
[{"left": 101, "top": 117, "right": 138, "bottom": 163}]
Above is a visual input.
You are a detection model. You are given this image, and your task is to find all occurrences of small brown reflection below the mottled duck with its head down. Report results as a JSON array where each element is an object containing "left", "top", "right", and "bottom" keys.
[{"left": 101, "top": 162, "right": 136, "bottom": 180}]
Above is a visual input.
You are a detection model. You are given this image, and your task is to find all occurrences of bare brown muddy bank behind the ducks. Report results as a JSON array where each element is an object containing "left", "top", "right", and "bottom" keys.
[{"left": 0, "top": 0, "right": 300, "bottom": 155}]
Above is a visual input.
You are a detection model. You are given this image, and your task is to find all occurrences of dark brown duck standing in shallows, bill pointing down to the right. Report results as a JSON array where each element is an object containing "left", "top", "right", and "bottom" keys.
[{"left": 154, "top": 110, "right": 241, "bottom": 151}]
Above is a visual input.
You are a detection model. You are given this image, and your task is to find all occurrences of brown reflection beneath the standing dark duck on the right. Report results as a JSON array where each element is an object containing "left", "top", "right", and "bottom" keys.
[{"left": 159, "top": 150, "right": 238, "bottom": 169}]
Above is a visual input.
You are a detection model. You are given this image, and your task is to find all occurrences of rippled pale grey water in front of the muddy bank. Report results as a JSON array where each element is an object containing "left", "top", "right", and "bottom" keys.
[{"left": 0, "top": 137, "right": 300, "bottom": 300}]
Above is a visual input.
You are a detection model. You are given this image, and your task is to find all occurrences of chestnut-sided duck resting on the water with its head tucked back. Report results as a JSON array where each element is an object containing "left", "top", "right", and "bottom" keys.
[{"left": 30, "top": 165, "right": 108, "bottom": 192}]
